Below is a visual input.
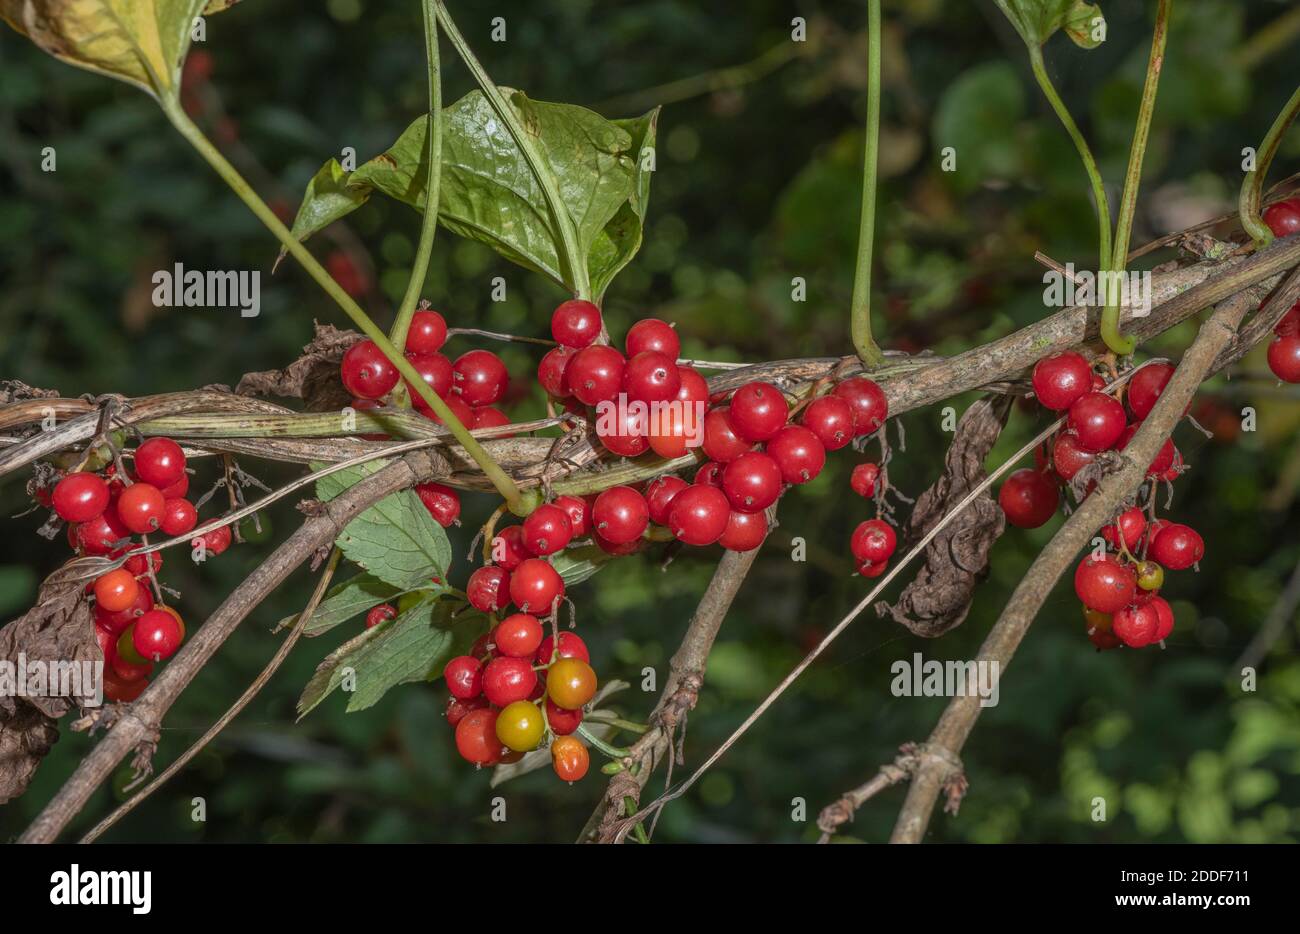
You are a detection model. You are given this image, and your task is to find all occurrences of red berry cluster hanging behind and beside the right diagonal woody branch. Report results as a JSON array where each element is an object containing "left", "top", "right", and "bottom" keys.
[{"left": 998, "top": 351, "right": 1205, "bottom": 649}]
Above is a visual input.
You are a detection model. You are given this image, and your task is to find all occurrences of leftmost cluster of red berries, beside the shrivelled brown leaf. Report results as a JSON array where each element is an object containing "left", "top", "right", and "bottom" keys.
[{"left": 38, "top": 437, "right": 231, "bottom": 701}]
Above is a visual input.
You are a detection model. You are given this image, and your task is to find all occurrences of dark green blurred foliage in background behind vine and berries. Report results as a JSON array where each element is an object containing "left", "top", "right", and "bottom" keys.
[{"left": 0, "top": 0, "right": 1300, "bottom": 842}]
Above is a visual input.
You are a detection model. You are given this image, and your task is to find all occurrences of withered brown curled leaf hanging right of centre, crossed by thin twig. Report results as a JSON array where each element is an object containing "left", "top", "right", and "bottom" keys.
[{"left": 876, "top": 395, "right": 1011, "bottom": 639}]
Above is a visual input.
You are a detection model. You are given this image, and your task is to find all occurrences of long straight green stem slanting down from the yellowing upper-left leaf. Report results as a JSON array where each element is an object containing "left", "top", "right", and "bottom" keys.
[{"left": 163, "top": 101, "right": 530, "bottom": 513}]
